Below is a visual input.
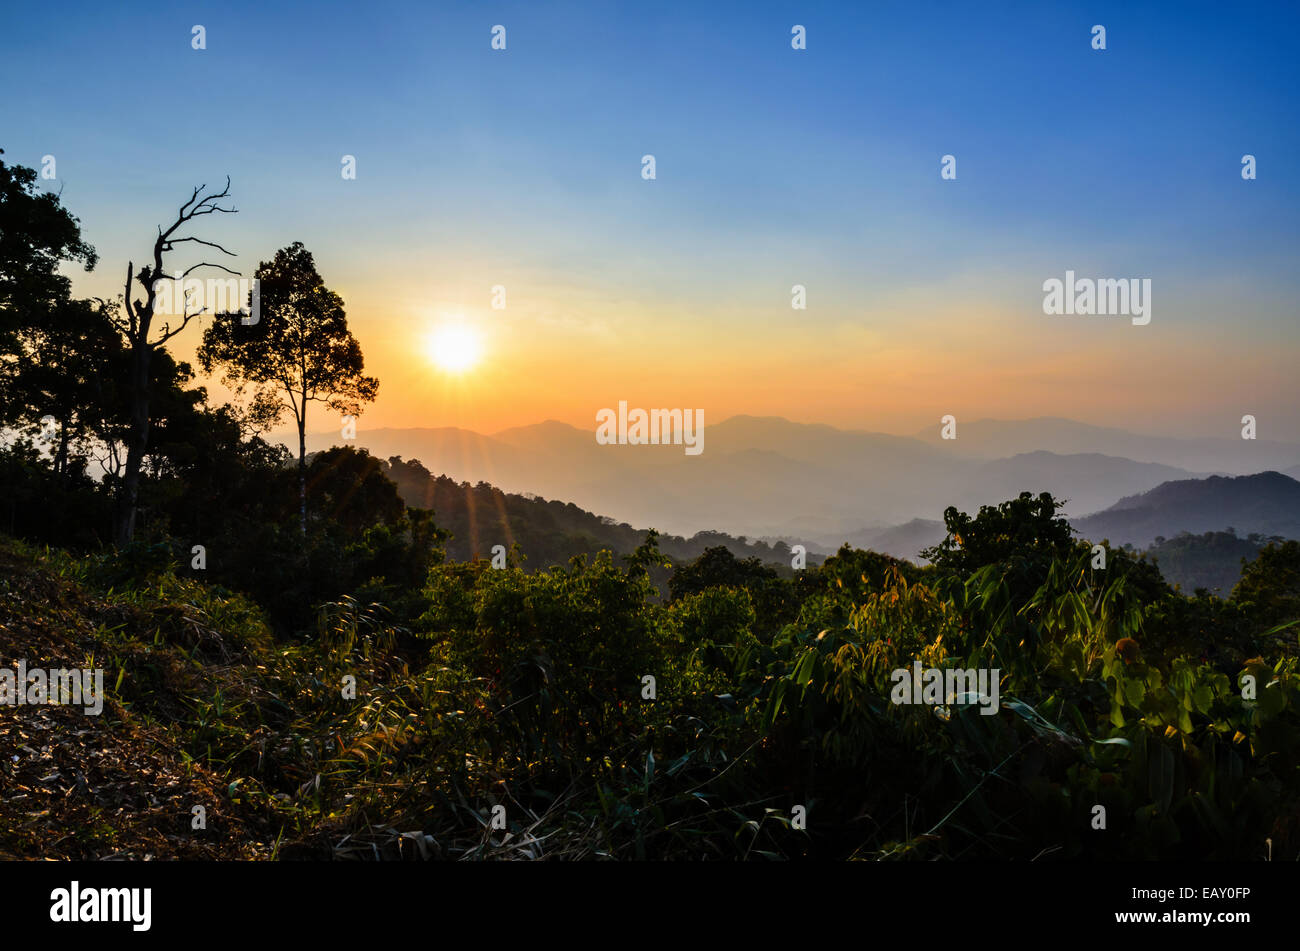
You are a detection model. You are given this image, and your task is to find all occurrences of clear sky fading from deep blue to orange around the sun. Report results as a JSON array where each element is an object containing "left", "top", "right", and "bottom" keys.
[{"left": 0, "top": 0, "right": 1300, "bottom": 439}]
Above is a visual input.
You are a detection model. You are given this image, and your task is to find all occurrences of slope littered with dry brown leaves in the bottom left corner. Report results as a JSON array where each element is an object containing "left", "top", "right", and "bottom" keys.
[{"left": 0, "top": 544, "right": 277, "bottom": 860}]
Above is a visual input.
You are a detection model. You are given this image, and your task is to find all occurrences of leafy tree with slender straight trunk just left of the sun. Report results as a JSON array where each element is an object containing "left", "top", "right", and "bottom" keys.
[{"left": 199, "top": 242, "right": 380, "bottom": 537}]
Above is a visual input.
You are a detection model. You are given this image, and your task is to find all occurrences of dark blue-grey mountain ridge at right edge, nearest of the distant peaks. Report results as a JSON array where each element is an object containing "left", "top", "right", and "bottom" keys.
[{"left": 1071, "top": 472, "right": 1300, "bottom": 548}]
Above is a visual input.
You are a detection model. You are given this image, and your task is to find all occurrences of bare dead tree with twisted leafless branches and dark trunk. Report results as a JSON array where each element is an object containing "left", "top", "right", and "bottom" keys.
[{"left": 114, "top": 177, "right": 239, "bottom": 547}]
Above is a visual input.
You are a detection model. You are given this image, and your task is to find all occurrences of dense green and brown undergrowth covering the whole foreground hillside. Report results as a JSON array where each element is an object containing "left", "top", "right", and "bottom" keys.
[{"left": 0, "top": 494, "right": 1300, "bottom": 859}]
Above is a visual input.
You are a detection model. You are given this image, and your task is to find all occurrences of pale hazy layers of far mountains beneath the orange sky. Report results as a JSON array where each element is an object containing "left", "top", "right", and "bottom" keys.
[{"left": 299, "top": 416, "right": 1300, "bottom": 553}]
